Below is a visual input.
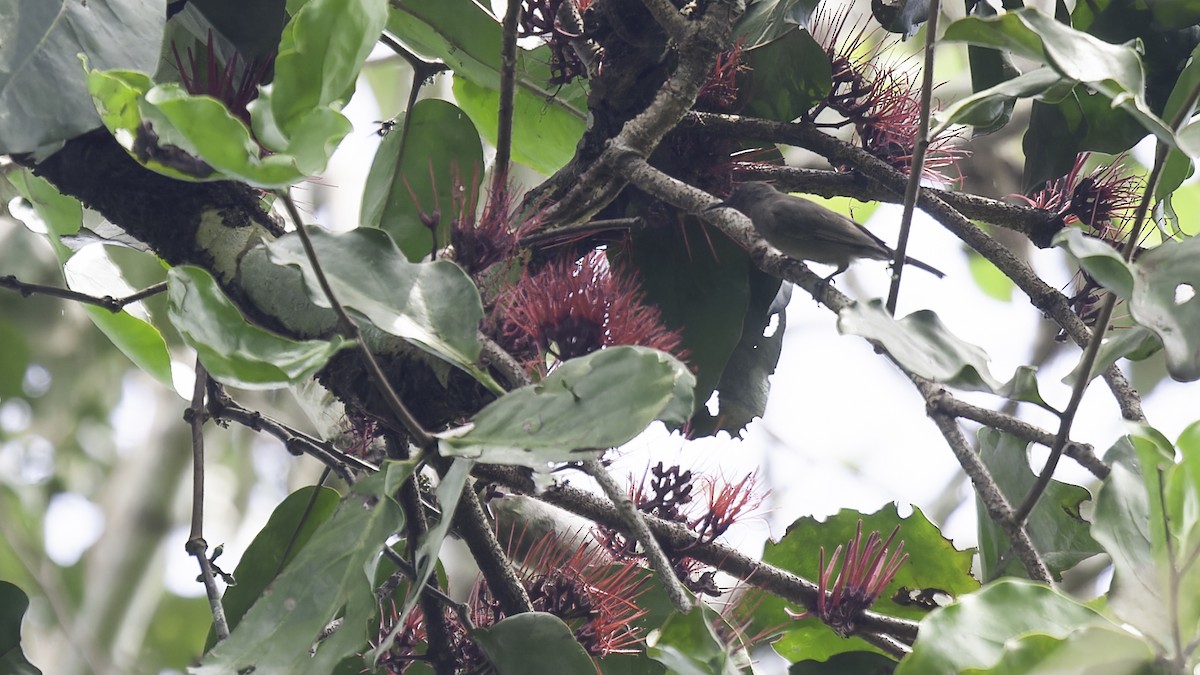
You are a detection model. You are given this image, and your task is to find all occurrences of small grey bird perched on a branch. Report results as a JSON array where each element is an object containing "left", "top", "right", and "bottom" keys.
[{"left": 712, "top": 183, "right": 946, "bottom": 281}]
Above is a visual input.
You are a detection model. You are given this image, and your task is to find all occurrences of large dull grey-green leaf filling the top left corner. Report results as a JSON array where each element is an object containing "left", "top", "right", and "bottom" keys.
[{"left": 0, "top": 0, "right": 166, "bottom": 154}]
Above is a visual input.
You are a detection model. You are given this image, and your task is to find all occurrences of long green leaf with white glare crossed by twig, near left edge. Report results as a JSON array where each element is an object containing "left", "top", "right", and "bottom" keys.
[{"left": 13, "top": 172, "right": 173, "bottom": 387}]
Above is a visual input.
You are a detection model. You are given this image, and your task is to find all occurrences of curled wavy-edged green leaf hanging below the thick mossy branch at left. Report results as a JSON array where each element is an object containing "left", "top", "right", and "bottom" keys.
[{"left": 168, "top": 265, "right": 349, "bottom": 389}]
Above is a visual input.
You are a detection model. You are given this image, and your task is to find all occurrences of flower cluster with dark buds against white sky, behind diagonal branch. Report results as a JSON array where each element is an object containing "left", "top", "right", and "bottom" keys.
[{"left": 596, "top": 461, "right": 763, "bottom": 596}]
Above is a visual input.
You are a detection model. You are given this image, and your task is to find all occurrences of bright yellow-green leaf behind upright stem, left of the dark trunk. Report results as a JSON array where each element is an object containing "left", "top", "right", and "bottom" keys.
[{"left": 451, "top": 74, "right": 583, "bottom": 175}]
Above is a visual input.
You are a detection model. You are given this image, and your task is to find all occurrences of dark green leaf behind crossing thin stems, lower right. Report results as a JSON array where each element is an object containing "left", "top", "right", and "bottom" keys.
[{"left": 977, "top": 428, "right": 1102, "bottom": 581}]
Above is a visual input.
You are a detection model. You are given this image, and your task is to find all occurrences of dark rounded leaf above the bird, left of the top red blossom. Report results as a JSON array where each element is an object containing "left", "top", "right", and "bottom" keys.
[{"left": 745, "top": 28, "right": 833, "bottom": 121}]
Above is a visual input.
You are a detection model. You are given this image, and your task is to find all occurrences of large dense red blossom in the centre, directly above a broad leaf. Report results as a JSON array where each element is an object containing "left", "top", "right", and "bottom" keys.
[{"left": 500, "top": 250, "right": 685, "bottom": 362}]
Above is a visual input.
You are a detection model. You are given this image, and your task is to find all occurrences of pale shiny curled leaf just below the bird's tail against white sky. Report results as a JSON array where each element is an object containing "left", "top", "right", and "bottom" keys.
[{"left": 838, "top": 299, "right": 1052, "bottom": 410}]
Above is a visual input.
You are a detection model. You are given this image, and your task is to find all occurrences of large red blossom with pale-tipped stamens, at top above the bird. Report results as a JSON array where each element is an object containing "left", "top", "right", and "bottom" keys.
[{"left": 805, "top": 5, "right": 967, "bottom": 181}]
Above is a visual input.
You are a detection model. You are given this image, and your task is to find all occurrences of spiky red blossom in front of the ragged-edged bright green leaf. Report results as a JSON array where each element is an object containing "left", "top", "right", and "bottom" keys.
[{"left": 787, "top": 520, "right": 908, "bottom": 638}]
